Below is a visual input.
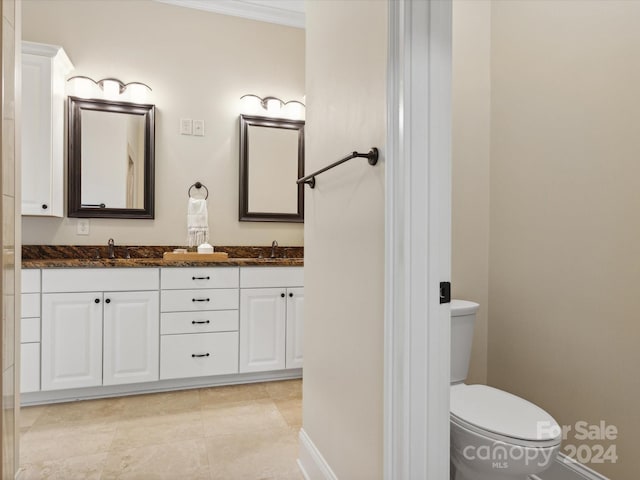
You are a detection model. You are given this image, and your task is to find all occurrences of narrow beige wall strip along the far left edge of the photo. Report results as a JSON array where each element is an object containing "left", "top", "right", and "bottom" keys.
[{"left": 0, "top": 0, "right": 20, "bottom": 479}]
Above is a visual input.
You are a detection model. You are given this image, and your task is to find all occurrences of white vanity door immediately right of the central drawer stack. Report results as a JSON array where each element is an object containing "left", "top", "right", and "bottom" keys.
[{"left": 240, "top": 288, "right": 287, "bottom": 373}]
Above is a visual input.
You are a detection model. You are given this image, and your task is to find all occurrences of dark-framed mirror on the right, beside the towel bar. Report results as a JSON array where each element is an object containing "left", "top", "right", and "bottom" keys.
[{"left": 240, "top": 115, "right": 304, "bottom": 222}]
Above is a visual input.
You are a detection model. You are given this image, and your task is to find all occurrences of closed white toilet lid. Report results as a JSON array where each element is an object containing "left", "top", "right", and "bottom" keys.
[{"left": 450, "top": 384, "right": 560, "bottom": 442}]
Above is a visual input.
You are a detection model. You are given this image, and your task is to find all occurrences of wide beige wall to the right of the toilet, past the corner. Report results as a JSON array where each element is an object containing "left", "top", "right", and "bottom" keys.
[{"left": 488, "top": 1, "right": 640, "bottom": 480}]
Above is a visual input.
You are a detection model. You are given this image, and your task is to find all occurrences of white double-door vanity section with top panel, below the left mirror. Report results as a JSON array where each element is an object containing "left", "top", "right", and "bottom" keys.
[{"left": 42, "top": 268, "right": 159, "bottom": 390}]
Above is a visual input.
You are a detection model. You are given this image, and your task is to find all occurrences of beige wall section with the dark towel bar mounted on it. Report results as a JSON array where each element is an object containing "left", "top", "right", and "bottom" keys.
[{"left": 303, "top": 0, "right": 387, "bottom": 480}]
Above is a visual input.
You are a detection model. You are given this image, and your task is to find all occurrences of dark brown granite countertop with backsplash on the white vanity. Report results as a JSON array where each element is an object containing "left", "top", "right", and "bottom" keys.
[{"left": 22, "top": 245, "right": 304, "bottom": 268}]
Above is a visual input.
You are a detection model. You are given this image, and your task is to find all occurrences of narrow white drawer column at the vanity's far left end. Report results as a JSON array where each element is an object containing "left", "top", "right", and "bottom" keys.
[{"left": 20, "top": 269, "right": 41, "bottom": 393}]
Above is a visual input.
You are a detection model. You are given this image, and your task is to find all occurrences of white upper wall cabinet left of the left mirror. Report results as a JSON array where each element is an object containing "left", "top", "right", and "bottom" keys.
[{"left": 22, "top": 42, "right": 73, "bottom": 217}]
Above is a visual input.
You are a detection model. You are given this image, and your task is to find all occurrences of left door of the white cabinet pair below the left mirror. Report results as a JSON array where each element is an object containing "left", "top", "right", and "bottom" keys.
[{"left": 42, "top": 292, "right": 103, "bottom": 390}]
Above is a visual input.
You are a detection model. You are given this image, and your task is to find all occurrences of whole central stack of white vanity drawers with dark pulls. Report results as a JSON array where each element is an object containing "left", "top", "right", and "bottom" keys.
[{"left": 160, "top": 267, "right": 239, "bottom": 380}]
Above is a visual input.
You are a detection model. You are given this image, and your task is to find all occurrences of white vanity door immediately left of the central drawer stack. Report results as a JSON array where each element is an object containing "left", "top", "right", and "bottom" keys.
[{"left": 102, "top": 291, "right": 160, "bottom": 385}]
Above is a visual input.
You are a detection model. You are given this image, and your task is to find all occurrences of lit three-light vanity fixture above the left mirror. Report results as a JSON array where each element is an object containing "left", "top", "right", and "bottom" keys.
[{"left": 67, "top": 75, "right": 151, "bottom": 103}]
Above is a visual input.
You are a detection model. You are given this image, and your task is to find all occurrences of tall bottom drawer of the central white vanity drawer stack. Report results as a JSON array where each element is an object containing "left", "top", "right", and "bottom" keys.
[{"left": 160, "top": 332, "right": 238, "bottom": 380}]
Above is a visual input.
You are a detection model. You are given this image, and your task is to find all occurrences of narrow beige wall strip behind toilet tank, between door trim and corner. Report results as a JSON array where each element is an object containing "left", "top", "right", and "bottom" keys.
[{"left": 451, "top": 0, "right": 491, "bottom": 383}]
